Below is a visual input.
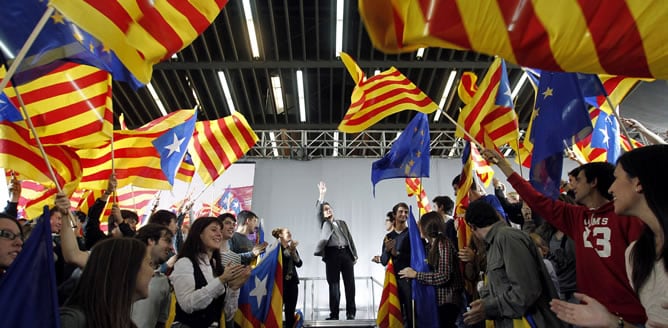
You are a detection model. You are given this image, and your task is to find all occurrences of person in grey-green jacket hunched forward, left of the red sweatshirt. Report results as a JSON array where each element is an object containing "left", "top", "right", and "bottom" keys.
[{"left": 464, "top": 200, "right": 565, "bottom": 327}]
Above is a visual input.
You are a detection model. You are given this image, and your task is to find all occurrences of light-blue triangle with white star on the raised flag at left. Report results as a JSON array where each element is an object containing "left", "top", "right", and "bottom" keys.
[{"left": 152, "top": 111, "right": 197, "bottom": 185}]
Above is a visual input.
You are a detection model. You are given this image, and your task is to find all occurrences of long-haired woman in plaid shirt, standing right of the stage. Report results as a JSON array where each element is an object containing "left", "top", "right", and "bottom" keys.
[{"left": 399, "top": 212, "right": 464, "bottom": 328}]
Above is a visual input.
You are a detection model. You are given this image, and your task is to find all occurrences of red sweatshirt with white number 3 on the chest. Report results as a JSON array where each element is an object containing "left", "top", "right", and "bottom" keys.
[{"left": 508, "top": 173, "right": 647, "bottom": 324}]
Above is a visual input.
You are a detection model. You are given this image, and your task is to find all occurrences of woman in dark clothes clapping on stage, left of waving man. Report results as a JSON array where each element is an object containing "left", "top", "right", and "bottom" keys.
[{"left": 271, "top": 228, "right": 302, "bottom": 328}]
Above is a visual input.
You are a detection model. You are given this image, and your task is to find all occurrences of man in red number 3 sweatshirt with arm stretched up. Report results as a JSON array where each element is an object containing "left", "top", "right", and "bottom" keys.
[{"left": 483, "top": 150, "right": 647, "bottom": 325}]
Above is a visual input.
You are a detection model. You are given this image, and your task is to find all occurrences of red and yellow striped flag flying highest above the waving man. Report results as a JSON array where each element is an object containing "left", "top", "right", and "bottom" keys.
[{"left": 338, "top": 52, "right": 438, "bottom": 133}]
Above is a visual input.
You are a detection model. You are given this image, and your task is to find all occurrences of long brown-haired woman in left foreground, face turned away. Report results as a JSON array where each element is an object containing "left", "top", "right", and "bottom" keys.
[{"left": 60, "top": 238, "right": 153, "bottom": 328}]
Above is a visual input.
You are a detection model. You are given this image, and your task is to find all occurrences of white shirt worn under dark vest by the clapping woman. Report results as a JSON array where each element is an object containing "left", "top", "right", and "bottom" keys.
[{"left": 169, "top": 254, "right": 225, "bottom": 313}]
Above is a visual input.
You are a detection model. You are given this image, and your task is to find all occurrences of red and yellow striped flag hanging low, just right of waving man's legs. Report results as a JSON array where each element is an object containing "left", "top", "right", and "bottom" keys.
[{"left": 376, "top": 260, "right": 404, "bottom": 328}]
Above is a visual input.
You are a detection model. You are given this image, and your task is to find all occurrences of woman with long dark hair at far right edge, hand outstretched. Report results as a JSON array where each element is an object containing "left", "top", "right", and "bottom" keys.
[{"left": 552, "top": 145, "right": 668, "bottom": 327}]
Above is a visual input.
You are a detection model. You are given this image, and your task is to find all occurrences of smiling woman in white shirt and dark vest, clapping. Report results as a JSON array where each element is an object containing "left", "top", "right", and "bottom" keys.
[{"left": 169, "top": 217, "right": 248, "bottom": 328}]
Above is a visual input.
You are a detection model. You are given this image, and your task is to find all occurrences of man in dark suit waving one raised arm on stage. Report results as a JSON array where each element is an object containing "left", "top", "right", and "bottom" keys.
[{"left": 313, "top": 181, "right": 357, "bottom": 320}]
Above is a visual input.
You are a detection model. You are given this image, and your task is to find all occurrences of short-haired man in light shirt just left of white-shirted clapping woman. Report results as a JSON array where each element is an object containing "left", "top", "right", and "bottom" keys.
[{"left": 132, "top": 223, "right": 173, "bottom": 328}]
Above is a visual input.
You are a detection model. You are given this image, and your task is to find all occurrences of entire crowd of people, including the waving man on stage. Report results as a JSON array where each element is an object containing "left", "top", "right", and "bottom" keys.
[{"left": 0, "top": 123, "right": 668, "bottom": 328}]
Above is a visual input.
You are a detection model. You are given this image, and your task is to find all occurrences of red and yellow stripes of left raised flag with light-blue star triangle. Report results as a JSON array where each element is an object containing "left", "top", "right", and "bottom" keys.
[{"left": 77, "top": 110, "right": 195, "bottom": 190}]
